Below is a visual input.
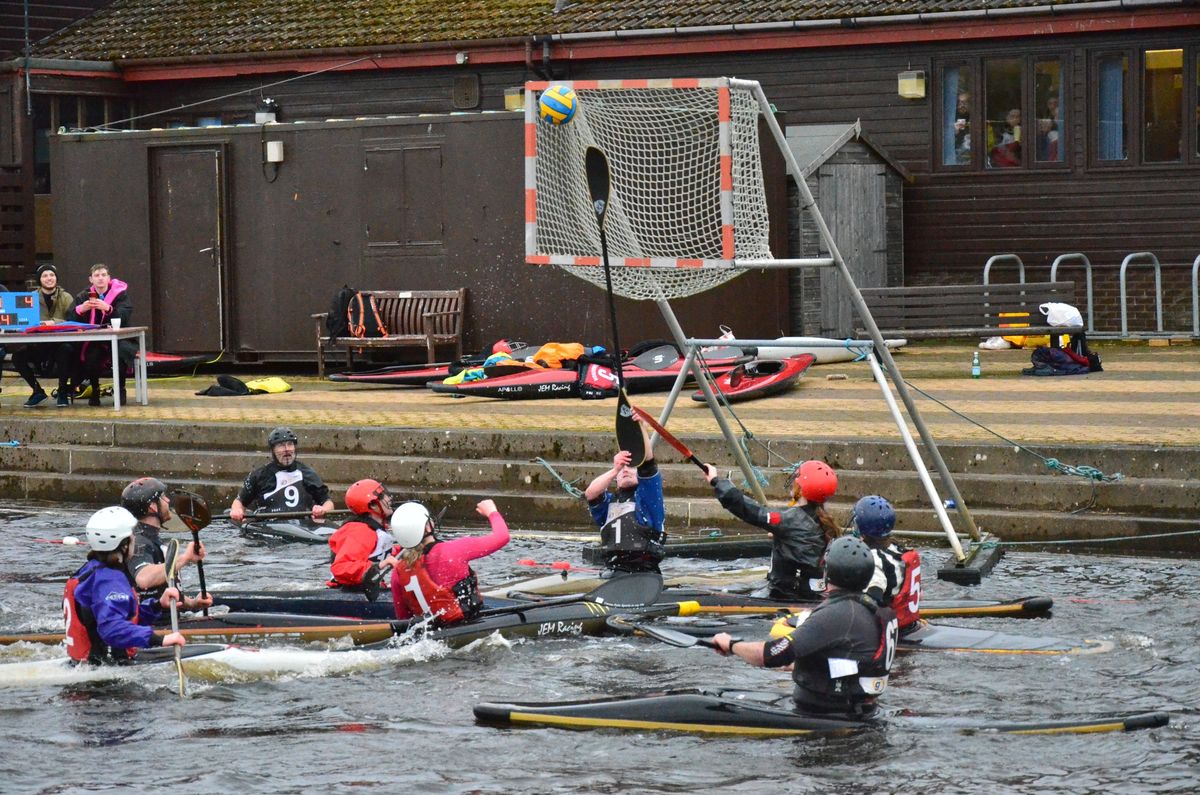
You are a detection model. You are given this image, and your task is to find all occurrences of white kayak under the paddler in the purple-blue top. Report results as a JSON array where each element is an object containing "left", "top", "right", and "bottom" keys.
[{"left": 0, "top": 644, "right": 432, "bottom": 687}]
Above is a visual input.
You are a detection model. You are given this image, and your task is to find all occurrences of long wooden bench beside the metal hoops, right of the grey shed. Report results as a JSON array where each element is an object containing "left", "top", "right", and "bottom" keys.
[{"left": 856, "top": 281, "right": 1084, "bottom": 346}]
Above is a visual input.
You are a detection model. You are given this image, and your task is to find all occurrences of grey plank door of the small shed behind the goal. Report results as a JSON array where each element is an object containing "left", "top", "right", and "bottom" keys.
[{"left": 817, "top": 163, "right": 888, "bottom": 339}]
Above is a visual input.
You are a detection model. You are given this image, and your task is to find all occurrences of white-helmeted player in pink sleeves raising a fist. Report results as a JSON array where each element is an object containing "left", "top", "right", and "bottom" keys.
[{"left": 384, "top": 500, "right": 510, "bottom": 626}]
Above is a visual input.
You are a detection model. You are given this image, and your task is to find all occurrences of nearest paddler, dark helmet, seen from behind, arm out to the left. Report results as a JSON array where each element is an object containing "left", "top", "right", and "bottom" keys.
[{"left": 713, "top": 536, "right": 899, "bottom": 719}]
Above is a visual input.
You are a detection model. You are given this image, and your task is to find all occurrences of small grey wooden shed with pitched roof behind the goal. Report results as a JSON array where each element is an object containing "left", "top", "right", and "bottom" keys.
[{"left": 786, "top": 121, "right": 911, "bottom": 339}]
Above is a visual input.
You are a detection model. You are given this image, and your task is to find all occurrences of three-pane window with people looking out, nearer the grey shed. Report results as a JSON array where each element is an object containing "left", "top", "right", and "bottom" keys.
[{"left": 936, "top": 55, "right": 1070, "bottom": 172}]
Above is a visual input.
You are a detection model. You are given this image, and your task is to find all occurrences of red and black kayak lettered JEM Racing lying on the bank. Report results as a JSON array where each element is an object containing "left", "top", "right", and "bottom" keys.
[{"left": 426, "top": 346, "right": 746, "bottom": 400}]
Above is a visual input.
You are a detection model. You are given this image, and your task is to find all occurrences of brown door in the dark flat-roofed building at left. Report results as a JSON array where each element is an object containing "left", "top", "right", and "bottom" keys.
[{"left": 150, "top": 148, "right": 224, "bottom": 353}]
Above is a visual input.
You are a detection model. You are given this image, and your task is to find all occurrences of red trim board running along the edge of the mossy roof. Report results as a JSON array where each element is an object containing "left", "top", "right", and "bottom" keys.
[{"left": 114, "top": 10, "right": 1200, "bottom": 83}]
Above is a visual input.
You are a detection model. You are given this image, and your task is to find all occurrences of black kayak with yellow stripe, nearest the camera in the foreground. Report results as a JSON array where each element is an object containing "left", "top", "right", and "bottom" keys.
[{"left": 474, "top": 688, "right": 1170, "bottom": 736}]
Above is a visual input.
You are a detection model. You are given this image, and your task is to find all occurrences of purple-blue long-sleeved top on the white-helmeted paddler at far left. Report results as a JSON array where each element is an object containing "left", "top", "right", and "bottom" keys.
[{"left": 67, "top": 561, "right": 162, "bottom": 650}]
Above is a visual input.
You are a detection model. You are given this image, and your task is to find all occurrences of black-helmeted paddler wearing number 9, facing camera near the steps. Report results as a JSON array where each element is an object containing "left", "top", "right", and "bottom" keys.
[{"left": 229, "top": 426, "right": 334, "bottom": 522}]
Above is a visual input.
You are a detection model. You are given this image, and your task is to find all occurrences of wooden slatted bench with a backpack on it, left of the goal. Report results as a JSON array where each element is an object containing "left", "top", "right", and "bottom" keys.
[{"left": 312, "top": 288, "right": 467, "bottom": 378}]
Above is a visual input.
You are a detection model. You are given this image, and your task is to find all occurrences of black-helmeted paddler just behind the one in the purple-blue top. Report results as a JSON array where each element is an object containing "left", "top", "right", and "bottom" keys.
[{"left": 121, "top": 478, "right": 212, "bottom": 608}]
